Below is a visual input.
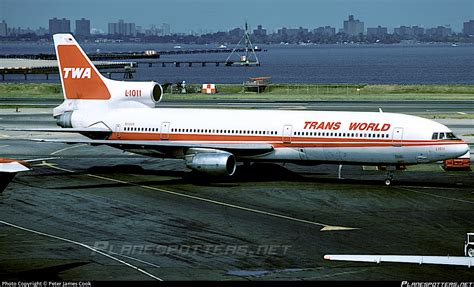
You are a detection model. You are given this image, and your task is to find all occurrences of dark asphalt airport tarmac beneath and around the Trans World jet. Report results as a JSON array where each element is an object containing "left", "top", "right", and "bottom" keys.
[{"left": 0, "top": 105, "right": 474, "bottom": 281}]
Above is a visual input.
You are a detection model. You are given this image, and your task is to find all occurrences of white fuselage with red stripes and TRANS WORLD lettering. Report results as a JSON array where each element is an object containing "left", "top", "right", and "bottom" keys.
[{"left": 68, "top": 108, "right": 469, "bottom": 165}]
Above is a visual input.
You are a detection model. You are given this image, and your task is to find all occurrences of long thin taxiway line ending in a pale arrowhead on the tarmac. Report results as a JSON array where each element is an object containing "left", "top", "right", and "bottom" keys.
[{"left": 41, "top": 161, "right": 359, "bottom": 231}]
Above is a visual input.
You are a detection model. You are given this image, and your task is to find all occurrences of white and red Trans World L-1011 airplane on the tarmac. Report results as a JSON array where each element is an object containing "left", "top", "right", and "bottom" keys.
[{"left": 4, "top": 34, "right": 469, "bottom": 185}]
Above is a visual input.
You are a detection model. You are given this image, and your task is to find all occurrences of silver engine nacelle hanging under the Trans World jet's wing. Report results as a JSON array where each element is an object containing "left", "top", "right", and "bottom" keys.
[{"left": 186, "top": 152, "right": 237, "bottom": 176}]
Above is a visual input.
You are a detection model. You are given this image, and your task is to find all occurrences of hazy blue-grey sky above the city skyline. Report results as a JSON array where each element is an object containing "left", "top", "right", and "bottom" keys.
[{"left": 0, "top": 0, "right": 474, "bottom": 33}]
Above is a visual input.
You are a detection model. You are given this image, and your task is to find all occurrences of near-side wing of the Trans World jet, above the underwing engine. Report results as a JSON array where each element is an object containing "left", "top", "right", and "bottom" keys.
[{"left": 29, "top": 139, "right": 273, "bottom": 156}]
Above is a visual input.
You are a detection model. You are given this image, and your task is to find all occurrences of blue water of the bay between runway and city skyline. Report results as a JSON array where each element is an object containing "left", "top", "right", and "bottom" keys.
[{"left": 0, "top": 43, "right": 474, "bottom": 84}]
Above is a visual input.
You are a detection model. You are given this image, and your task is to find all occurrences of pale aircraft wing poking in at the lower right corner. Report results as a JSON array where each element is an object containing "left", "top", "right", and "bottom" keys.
[{"left": 324, "top": 255, "right": 474, "bottom": 267}]
